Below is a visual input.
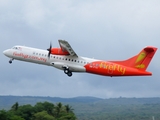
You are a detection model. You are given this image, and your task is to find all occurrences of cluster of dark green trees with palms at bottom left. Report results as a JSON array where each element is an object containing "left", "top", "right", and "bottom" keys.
[{"left": 0, "top": 102, "right": 76, "bottom": 120}]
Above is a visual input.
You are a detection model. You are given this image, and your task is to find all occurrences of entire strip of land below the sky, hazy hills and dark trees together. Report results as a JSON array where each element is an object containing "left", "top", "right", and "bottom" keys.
[{"left": 0, "top": 96, "right": 160, "bottom": 120}]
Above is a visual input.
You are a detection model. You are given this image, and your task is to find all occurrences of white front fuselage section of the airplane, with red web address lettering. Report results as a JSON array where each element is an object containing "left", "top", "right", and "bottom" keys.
[{"left": 3, "top": 46, "right": 98, "bottom": 72}]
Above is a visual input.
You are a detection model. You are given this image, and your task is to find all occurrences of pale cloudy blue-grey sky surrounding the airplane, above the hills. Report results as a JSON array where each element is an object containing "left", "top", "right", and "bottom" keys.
[{"left": 0, "top": 0, "right": 160, "bottom": 98}]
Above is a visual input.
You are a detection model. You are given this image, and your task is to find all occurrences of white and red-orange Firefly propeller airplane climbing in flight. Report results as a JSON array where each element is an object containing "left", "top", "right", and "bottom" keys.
[{"left": 3, "top": 40, "right": 158, "bottom": 77}]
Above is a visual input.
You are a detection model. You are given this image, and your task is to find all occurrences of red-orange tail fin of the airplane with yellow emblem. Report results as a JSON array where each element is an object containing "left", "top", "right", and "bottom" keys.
[{"left": 112, "top": 46, "right": 157, "bottom": 70}]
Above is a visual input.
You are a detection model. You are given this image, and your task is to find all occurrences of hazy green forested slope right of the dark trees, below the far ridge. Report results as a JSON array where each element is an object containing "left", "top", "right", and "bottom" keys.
[{"left": 75, "top": 103, "right": 160, "bottom": 120}]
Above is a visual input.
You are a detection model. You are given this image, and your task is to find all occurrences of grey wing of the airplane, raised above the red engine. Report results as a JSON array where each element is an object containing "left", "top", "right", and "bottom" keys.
[{"left": 58, "top": 40, "right": 78, "bottom": 57}]
